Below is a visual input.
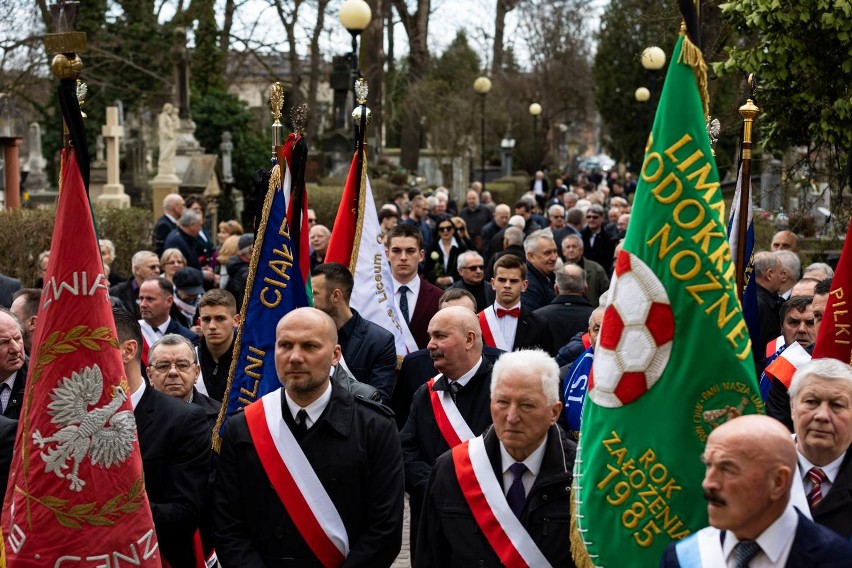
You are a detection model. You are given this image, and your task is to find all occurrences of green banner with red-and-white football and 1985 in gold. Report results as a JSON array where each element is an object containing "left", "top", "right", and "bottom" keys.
[{"left": 574, "top": 35, "right": 762, "bottom": 567}]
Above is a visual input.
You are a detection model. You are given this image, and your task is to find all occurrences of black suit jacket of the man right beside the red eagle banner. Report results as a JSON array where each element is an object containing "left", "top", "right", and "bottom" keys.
[{"left": 133, "top": 387, "right": 212, "bottom": 567}]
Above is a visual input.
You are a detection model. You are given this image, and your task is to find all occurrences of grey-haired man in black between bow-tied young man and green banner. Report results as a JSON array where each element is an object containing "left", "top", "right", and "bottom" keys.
[{"left": 535, "top": 263, "right": 595, "bottom": 347}]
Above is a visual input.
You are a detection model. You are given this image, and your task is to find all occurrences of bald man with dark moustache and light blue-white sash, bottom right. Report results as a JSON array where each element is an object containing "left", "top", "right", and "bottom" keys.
[{"left": 660, "top": 415, "right": 852, "bottom": 568}]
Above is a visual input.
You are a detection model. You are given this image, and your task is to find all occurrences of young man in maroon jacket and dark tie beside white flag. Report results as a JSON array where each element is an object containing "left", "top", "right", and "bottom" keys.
[{"left": 385, "top": 223, "right": 443, "bottom": 351}]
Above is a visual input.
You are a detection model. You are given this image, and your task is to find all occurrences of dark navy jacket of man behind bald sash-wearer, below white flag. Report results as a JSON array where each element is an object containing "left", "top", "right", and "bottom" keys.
[{"left": 338, "top": 310, "right": 396, "bottom": 404}]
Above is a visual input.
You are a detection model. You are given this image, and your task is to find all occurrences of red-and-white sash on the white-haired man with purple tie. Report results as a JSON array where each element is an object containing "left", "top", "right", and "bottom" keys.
[{"left": 453, "top": 436, "right": 552, "bottom": 568}]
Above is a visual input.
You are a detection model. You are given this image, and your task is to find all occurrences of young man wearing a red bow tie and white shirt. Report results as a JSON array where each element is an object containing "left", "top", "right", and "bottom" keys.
[{"left": 479, "top": 255, "right": 556, "bottom": 355}]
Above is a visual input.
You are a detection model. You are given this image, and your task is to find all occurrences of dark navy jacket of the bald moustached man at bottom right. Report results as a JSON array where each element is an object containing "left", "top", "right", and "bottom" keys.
[{"left": 660, "top": 510, "right": 852, "bottom": 568}]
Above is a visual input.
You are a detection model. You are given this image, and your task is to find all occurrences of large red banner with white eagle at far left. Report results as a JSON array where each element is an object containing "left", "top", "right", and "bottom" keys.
[{"left": 2, "top": 150, "right": 161, "bottom": 567}]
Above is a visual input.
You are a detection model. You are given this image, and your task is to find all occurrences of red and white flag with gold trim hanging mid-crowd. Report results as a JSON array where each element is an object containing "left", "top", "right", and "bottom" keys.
[{"left": 325, "top": 151, "right": 417, "bottom": 358}]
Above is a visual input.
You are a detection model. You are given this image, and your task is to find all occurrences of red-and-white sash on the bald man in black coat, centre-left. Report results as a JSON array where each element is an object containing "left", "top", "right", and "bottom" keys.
[{"left": 245, "top": 389, "right": 349, "bottom": 567}]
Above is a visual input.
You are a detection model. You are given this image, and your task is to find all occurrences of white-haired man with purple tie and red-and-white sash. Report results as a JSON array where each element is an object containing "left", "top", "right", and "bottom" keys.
[{"left": 414, "top": 350, "right": 576, "bottom": 568}]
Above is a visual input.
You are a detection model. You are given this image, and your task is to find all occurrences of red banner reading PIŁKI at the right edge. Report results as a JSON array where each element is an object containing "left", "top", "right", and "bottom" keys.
[{"left": 813, "top": 221, "right": 852, "bottom": 364}]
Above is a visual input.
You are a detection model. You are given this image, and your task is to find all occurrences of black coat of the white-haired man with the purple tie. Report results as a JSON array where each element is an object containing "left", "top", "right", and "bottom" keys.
[{"left": 415, "top": 426, "right": 577, "bottom": 568}]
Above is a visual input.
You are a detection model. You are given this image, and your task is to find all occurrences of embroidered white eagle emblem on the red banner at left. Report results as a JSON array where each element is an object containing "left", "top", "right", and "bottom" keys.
[{"left": 33, "top": 365, "right": 136, "bottom": 491}]
